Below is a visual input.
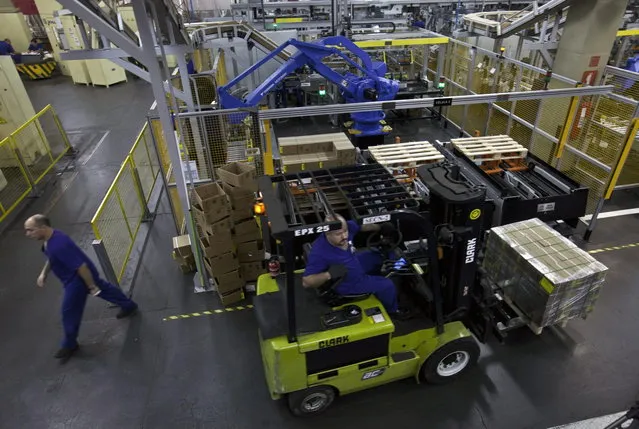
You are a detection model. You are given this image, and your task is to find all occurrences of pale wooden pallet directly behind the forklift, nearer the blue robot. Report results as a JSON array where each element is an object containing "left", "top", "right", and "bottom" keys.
[{"left": 368, "top": 141, "right": 444, "bottom": 169}]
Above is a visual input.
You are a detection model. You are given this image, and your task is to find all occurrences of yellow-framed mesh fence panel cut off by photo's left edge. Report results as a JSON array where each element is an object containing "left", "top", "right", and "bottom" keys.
[{"left": 0, "top": 138, "right": 32, "bottom": 221}]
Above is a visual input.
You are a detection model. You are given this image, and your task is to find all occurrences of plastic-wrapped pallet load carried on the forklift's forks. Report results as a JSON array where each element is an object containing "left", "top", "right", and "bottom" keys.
[{"left": 483, "top": 219, "right": 608, "bottom": 327}]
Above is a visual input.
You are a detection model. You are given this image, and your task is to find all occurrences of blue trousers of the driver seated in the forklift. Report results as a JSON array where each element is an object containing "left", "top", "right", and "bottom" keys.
[{"left": 337, "top": 251, "right": 397, "bottom": 313}]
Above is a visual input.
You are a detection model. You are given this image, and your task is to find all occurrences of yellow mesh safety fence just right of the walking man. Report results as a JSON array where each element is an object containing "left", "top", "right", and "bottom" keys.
[{"left": 91, "top": 123, "right": 161, "bottom": 281}]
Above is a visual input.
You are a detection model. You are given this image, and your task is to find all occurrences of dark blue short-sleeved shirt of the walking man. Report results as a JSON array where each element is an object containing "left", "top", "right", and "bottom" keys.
[{"left": 42, "top": 229, "right": 99, "bottom": 285}]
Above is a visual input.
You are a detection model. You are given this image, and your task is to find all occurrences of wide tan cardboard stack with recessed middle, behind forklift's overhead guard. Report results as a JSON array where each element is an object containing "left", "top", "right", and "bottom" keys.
[{"left": 278, "top": 133, "right": 357, "bottom": 173}]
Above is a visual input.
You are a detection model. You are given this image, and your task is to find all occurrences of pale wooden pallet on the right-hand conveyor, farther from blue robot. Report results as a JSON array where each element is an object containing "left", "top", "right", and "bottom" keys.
[{"left": 451, "top": 136, "right": 528, "bottom": 161}]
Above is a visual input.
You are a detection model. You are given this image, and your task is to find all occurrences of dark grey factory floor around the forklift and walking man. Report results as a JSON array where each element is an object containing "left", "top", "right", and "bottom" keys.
[{"left": 0, "top": 78, "right": 639, "bottom": 429}]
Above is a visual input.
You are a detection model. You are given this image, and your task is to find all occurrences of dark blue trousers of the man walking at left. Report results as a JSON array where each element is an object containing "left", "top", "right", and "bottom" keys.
[{"left": 62, "top": 279, "right": 136, "bottom": 349}]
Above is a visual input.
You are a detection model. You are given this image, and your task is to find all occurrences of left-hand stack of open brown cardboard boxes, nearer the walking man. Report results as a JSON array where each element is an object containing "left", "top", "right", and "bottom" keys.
[{"left": 193, "top": 183, "right": 244, "bottom": 305}]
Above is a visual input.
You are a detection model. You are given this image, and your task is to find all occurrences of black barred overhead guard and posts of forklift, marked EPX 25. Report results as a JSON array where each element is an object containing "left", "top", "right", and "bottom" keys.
[{"left": 258, "top": 164, "right": 444, "bottom": 342}]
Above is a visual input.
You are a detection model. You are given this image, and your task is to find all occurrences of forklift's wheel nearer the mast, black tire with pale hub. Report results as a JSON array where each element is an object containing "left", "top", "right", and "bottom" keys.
[{"left": 422, "top": 337, "right": 479, "bottom": 384}]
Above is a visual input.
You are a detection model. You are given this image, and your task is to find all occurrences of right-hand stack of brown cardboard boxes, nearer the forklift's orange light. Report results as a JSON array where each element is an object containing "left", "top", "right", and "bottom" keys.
[{"left": 217, "top": 162, "right": 264, "bottom": 282}]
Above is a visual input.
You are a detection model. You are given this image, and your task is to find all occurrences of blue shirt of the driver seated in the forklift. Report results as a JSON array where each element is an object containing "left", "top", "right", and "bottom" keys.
[{"left": 304, "top": 220, "right": 366, "bottom": 290}]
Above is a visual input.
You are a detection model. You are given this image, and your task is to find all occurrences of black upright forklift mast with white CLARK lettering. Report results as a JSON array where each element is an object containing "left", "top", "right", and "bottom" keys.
[{"left": 417, "top": 162, "right": 486, "bottom": 321}]
